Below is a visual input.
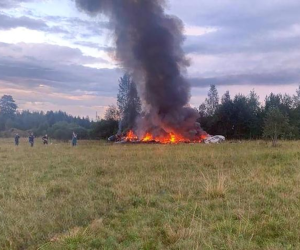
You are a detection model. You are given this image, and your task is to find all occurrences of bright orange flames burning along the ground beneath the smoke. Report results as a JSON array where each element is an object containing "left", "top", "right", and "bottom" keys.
[{"left": 125, "top": 130, "right": 208, "bottom": 144}]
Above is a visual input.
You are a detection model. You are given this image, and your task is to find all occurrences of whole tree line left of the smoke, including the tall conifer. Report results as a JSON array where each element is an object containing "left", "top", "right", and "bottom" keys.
[{"left": 0, "top": 74, "right": 141, "bottom": 140}]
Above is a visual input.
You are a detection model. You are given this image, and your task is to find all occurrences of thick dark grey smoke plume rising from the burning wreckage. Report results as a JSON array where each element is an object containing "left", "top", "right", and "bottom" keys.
[{"left": 75, "top": 0, "right": 205, "bottom": 139}]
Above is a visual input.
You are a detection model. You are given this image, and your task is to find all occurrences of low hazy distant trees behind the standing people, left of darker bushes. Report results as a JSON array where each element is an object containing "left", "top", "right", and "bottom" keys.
[{"left": 0, "top": 95, "right": 93, "bottom": 140}]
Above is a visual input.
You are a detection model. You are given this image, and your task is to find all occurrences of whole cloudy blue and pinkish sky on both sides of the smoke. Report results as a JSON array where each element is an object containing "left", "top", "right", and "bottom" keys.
[{"left": 0, "top": 0, "right": 300, "bottom": 119}]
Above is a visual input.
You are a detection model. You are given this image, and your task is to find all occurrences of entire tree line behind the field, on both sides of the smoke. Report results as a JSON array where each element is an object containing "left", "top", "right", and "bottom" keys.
[{"left": 0, "top": 74, "right": 300, "bottom": 145}]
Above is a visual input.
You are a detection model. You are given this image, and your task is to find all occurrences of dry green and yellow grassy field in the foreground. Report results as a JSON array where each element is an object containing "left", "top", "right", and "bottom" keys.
[{"left": 0, "top": 139, "right": 300, "bottom": 250}]
